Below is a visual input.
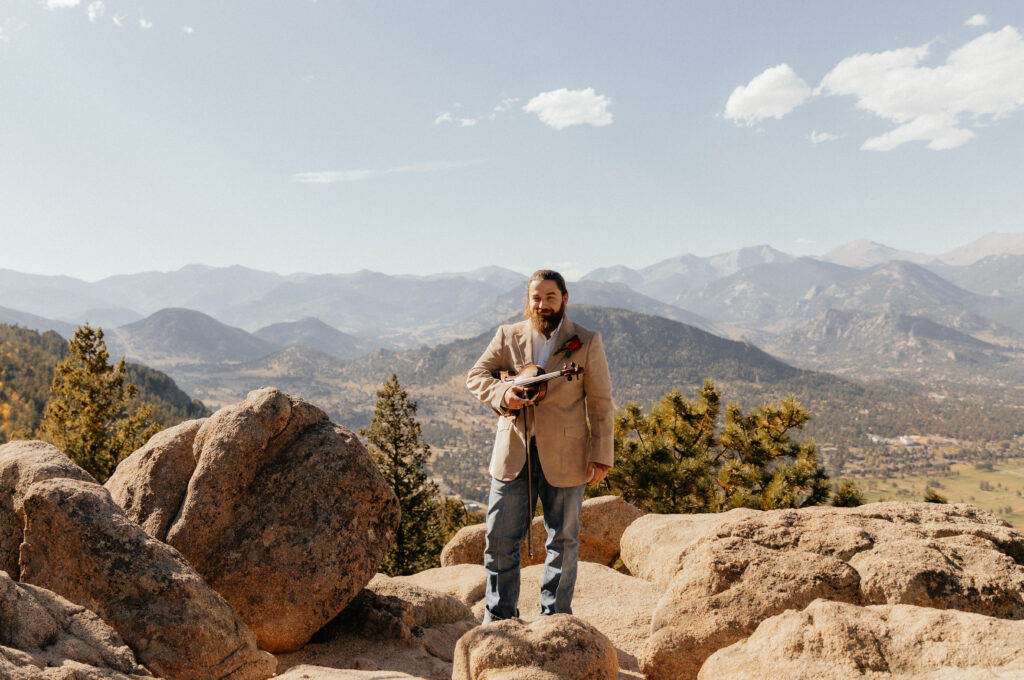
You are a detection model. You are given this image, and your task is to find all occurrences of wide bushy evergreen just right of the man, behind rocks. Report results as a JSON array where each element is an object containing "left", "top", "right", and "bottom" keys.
[{"left": 592, "top": 380, "right": 828, "bottom": 513}]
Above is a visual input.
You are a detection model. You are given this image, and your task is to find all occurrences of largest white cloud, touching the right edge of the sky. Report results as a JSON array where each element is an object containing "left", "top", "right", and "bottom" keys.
[{"left": 817, "top": 26, "right": 1024, "bottom": 151}]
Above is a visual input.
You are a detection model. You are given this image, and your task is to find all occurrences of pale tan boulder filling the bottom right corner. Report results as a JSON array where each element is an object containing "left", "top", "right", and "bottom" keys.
[{"left": 698, "top": 600, "right": 1024, "bottom": 680}]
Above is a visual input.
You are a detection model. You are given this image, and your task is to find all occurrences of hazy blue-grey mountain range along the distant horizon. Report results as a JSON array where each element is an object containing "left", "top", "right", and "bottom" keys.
[{"left": 0, "top": 233, "right": 1024, "bottom": 384}]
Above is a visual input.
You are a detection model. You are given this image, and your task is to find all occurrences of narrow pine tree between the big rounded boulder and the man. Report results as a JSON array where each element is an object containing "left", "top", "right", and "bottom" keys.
[{"left": 359, "top": 374, "right": 458, "bottom": 576}]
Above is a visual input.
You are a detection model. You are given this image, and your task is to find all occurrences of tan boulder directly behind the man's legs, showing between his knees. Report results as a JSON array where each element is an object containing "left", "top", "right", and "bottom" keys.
[{"left": 441, "top": 496, "right": 643, "bottom": 566}]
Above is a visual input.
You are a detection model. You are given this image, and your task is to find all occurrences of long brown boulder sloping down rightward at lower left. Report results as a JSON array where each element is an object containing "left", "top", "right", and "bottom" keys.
[{"left": 20, "top": 478, "right": 276, "bottom": 680}]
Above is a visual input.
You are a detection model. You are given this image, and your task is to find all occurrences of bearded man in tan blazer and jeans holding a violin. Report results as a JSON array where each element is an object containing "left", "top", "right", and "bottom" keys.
[{"left": 466, "top": 269, "right": 613, "bottom": 624}]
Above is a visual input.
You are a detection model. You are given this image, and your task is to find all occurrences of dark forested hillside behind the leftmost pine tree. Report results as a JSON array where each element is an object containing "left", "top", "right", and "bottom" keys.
[{"left": 0, "top": 324, "right": 210, "bottom": 442}]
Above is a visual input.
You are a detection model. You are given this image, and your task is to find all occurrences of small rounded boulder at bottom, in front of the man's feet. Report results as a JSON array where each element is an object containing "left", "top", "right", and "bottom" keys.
[{"left": 452, "top": 613, "right": 618, "bottom": 680}]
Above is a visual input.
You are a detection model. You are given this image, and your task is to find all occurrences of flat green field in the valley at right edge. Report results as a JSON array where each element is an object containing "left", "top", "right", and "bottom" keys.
[{"left": 854, "top": 459, "right": 1024, "bottom": 527}]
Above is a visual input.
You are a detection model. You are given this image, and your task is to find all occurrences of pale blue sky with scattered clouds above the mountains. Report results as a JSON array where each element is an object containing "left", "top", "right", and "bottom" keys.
[{"left": 0, "top": 0, "right": 1024, "bottom": 280}]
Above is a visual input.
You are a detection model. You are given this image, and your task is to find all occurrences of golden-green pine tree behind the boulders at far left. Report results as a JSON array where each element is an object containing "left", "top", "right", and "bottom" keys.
[{"left": 40, "top": 324, "right": 160, "bottom": 483}]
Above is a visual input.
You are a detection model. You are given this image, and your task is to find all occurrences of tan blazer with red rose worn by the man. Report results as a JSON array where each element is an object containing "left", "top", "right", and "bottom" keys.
[{"left": 466, "top": 316, "right": 614, "bottom": 486}]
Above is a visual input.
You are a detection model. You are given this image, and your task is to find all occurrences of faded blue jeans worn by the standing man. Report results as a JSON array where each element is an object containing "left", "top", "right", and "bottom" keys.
[{"left": 483, "top": 441, "right": 587, "bottom": 624}]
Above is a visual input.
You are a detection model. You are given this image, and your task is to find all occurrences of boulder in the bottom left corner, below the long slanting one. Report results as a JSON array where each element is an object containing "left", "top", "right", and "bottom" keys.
[{"left": 0, "top": 571, "right": 153, "bottom": 680}]
